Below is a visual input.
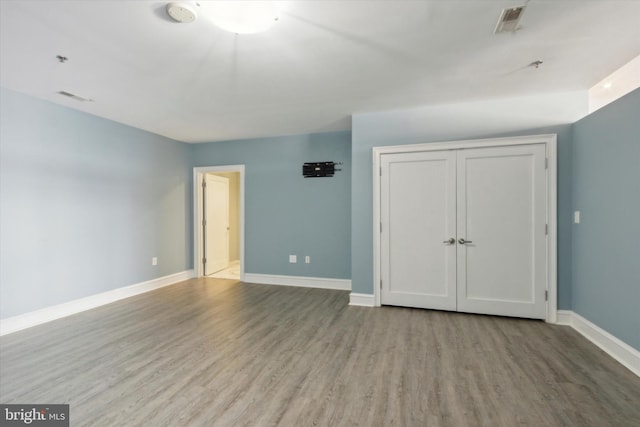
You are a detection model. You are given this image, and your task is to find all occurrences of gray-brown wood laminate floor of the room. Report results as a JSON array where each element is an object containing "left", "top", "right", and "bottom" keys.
[{"left": 0, "top": 279, "right": 640, "bottom": 427}]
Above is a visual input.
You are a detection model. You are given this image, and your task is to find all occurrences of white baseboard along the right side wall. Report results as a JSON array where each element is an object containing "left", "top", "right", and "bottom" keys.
[{"left": 557, "top": 310, "right": 640, "bottom": 377}]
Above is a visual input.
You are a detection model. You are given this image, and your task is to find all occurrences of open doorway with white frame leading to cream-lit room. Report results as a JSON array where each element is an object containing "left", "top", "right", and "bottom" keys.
[{"left": 193, "top": 165, "right": 244, "bottom": 280}]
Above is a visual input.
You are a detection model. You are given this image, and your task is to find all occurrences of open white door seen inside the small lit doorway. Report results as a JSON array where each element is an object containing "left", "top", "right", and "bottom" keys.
[{"left": 203, "top": 174, "right": 229, "bottom": 276}]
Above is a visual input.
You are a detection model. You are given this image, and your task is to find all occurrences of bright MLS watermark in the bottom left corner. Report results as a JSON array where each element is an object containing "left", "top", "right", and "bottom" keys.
[{"left": 0, "top": 403, "right": 69, "bottom": 427}]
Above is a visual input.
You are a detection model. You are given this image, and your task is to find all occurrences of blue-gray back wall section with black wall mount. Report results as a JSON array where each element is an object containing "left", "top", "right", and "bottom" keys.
[{"left": 192, "top": 132, "right": 351, "bottom": 279}]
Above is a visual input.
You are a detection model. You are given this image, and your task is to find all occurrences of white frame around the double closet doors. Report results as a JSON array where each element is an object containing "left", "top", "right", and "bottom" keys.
[{"left": 373, "top": 134, "right": 558, "bottom": 323}]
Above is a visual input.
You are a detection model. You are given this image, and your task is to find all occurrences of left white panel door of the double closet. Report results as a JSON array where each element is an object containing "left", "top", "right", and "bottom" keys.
[{"left": 380, "top": 151, "right": 457, "bottom": 310}]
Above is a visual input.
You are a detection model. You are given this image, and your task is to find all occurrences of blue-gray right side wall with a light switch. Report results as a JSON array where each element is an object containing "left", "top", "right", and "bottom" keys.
[{"left": 572, "top": 89, "right": 640, "bottom": 350}]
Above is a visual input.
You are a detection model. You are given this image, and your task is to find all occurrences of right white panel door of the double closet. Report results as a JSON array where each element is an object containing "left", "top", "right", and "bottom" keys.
[{"left": 457, "top": 144, "right": 546, "bottom": 319}]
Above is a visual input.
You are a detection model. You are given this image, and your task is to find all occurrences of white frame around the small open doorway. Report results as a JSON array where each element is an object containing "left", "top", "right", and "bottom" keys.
[{"left": 193, "top": 165, "right": 244, "bottom": 280}]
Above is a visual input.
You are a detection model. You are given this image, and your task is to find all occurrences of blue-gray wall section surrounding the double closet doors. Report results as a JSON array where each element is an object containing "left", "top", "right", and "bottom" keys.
[{"left": 351, "top": 111, "right": 572, "bottom": 309}]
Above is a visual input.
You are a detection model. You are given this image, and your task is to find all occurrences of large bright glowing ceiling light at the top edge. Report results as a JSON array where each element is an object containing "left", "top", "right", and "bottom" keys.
[{"left": 200, "top": 1, "right": 278, "bottom": 34}]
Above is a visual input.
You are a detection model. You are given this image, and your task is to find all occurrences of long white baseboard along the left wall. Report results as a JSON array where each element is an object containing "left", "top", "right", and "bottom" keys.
[{"left": 0, "top": 270, "right": 195, "bottom": 336}]
